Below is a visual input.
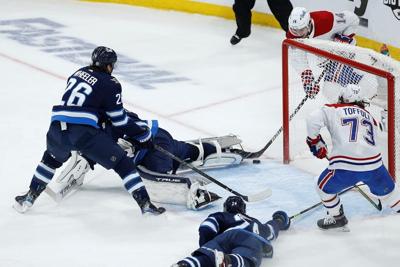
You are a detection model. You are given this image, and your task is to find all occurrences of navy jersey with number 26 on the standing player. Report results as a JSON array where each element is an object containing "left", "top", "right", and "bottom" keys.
[{"left": 51, "top": 66, "right": 151, "bottom": 139}]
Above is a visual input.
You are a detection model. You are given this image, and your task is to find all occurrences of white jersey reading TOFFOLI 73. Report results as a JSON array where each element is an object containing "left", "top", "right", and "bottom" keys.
[{"left": 307, "top": 104, "right": 382, "bottom": 171}]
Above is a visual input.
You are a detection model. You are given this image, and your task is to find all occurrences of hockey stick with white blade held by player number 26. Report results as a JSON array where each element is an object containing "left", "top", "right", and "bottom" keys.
[{"left": 154, "top": 145, "right": 272, "bottom": 202}]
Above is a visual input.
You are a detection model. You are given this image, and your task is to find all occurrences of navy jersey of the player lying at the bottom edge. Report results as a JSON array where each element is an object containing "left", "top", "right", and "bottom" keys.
[{"left": 199, "top": 212, "right": 276, "bottom": 246}]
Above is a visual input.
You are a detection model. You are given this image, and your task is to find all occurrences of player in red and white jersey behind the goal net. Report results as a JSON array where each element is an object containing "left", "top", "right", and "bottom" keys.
[{"left": 286, "top": 7, "right": 362, "bottom": 98}]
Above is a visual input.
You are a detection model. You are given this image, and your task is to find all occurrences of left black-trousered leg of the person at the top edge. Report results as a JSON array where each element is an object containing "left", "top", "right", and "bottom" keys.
[{"left": 230, "top": 0, "right": 255, "bottom": 45}]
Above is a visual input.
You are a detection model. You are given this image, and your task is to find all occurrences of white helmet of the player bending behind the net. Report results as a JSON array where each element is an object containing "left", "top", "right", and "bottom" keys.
[{"left": 289, "top": 7, "right": 312, "bottom": 38}]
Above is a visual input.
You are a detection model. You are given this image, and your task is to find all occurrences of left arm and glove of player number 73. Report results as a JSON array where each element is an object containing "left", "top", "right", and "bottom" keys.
[{"left": 306, "top": 109, "right": 328, "bottom": 159}]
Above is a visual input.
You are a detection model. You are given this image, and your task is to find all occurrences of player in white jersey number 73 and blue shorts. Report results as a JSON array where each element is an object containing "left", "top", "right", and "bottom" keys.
[{"left": 307, "top": 84, "right": 400, "bottom": 230}]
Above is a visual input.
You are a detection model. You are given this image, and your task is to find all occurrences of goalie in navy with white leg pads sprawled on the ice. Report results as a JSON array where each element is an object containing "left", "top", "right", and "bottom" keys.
[{"left": 43, "top": 111, "right": 247, "bottom": 210}]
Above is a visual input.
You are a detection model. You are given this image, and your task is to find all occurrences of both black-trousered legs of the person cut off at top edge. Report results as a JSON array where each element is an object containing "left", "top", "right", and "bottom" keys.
[{"left": 230, "top": 0, "right": 293, "bottom": 45}]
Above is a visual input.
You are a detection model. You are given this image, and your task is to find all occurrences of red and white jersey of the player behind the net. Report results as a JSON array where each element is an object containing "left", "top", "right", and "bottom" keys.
[{"left": 286, "top": 10, "right": 359, "bottom": 40}]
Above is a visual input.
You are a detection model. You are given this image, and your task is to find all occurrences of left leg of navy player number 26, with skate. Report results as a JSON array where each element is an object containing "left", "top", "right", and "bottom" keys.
[{"left": 14, "top": 122, "right": 70, "bottom": 213}]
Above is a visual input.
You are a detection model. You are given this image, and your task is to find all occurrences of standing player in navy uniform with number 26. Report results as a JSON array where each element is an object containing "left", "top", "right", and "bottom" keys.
[{"left": 14, "top": 46, "right": 165, "bottom": 214}]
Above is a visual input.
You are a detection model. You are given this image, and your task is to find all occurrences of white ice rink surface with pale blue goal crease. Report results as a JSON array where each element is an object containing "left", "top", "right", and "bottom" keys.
[{"left": 0, "top": 0, "right": 400, "bottom": 267}]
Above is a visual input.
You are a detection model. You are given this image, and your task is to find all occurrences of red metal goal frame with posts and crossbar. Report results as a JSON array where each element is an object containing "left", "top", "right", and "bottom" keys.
[{"left": 282, "top": 39, "right": 396, "bottom": 178}]
